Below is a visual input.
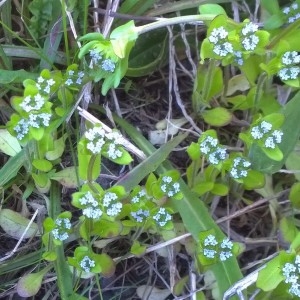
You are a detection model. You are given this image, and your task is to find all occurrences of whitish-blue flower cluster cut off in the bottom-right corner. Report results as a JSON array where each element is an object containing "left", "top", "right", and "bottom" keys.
[{"left": 282, "top": 255, "right": 300, "bottom": 297}]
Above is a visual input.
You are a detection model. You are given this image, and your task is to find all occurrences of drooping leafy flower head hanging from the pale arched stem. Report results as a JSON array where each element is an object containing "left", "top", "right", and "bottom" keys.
[{"left": 78, "top": 21, "right": 138, "bottom": 95}]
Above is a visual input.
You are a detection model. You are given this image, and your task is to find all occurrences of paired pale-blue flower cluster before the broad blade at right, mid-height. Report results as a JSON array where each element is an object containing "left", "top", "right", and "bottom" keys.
[{"left": 250, "top": 121, "right": 283, "bottom": 149}]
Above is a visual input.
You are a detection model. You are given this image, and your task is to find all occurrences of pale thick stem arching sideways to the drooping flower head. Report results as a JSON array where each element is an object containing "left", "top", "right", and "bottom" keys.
[{"left": 136, "top": 14, "right": 216, "bottom": 35}]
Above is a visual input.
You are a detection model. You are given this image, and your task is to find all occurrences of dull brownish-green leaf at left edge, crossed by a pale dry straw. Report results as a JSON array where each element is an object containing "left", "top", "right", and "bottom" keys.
[{"left": 0, "top": 208, "right": 40, "bottom": 239}]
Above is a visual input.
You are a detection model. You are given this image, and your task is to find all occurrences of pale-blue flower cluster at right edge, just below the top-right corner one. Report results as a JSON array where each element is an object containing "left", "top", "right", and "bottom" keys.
[{"left": 278, "top": 51, "right": 300, "bottom": 81}]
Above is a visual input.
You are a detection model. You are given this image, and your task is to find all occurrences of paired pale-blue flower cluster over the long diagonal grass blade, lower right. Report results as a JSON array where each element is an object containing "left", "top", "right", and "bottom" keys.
[{"left": 203, "top": 234, "right": 233, "bottom": 261}]
